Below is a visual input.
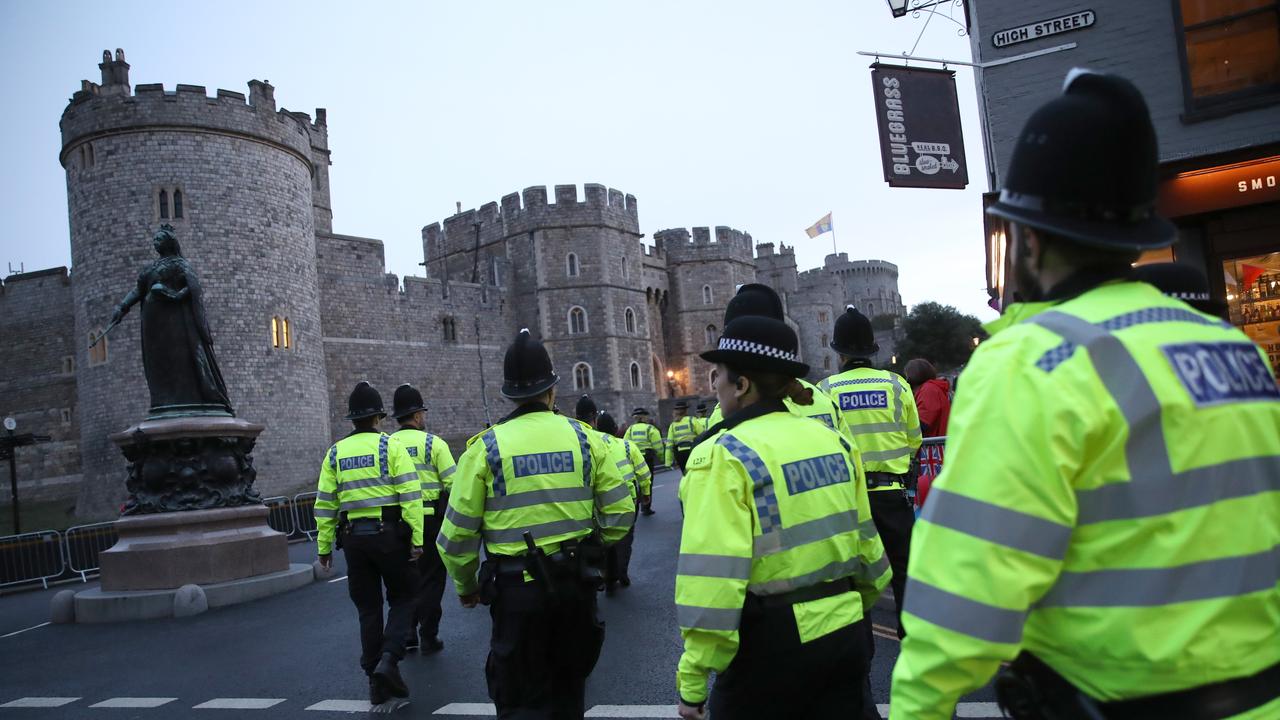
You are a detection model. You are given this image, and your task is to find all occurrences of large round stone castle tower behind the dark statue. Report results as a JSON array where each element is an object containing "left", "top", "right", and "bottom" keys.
[{"left": 59, "top": 50, "right": 329, "bottom": 516}]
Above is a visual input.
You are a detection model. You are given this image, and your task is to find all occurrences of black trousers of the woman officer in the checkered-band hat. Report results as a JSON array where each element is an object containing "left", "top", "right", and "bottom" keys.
[{"left": 707, "top": 600, "right": 870, "bottom": 720}]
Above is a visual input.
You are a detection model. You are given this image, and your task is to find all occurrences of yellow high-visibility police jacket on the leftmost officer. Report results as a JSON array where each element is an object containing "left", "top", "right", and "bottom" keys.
[{"left": 315, "top": 430, "right": 422, "bottom": 555}]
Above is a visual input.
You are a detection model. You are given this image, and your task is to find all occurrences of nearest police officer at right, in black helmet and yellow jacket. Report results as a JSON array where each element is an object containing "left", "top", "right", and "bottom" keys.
[{"left": 891, "top": 70, "right": 1280, "bottom": 720}]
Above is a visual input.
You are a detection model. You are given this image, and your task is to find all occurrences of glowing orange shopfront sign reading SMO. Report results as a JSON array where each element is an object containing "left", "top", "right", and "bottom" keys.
[{"left": 1160, "top": 156, "right": 1280, "bottom": 218}]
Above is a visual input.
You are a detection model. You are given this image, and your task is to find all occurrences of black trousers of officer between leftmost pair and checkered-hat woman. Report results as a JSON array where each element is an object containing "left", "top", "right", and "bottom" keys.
[{"left": 485, "top": 574, "right": 604, "bottom": 720}]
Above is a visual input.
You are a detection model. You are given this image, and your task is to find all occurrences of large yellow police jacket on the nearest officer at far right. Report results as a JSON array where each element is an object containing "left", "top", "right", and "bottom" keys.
[{"left": 891, "top": 282, "right": 1280, "bottom": 720}]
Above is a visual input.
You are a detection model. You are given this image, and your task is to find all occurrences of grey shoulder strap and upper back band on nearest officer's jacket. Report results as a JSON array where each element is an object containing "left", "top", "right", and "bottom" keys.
[{"left": 1029, "top": 311, "right": 1280, "bottom": 517}]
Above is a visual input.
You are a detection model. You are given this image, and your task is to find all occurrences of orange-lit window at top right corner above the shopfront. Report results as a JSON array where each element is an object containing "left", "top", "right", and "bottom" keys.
[{"left": 1175, "top": 0, "right": 1280, "bottom": 114}]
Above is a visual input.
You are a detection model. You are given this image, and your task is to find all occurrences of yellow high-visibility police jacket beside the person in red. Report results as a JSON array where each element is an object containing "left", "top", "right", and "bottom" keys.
[{"left": 818, "top": 368, "right": 923, "bottom": 476}]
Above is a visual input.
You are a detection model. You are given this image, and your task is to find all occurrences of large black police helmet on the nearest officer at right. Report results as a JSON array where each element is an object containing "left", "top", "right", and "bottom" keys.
[{"left": 987, "top": 69, "right": 1174, "bottom": 251}]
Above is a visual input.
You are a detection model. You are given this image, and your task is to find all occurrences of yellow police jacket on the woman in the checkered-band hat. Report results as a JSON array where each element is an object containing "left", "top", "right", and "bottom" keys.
[{"left": 676, "top": 402, "right": 892, "bottom": 703}]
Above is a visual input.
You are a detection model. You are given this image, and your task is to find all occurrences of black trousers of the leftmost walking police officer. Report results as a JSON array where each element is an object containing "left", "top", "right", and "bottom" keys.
[{"left": 342, "top": 524, "right": 413, "bottom": 674}]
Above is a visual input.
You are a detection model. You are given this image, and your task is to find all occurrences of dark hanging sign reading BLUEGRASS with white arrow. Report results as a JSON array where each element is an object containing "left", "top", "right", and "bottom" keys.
[{"left": 872, "top": 63, "right": 969, "bottom": 190}]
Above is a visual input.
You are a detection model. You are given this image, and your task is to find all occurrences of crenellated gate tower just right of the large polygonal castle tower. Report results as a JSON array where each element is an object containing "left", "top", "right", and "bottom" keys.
[{"left": 653, "top": 225, "right": 755, "bottom": 395}]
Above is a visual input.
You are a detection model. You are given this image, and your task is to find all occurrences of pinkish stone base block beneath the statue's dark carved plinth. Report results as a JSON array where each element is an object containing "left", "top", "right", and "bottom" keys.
[{"left": 99, "top": 505, "right": 289, "bottom": 591}]
